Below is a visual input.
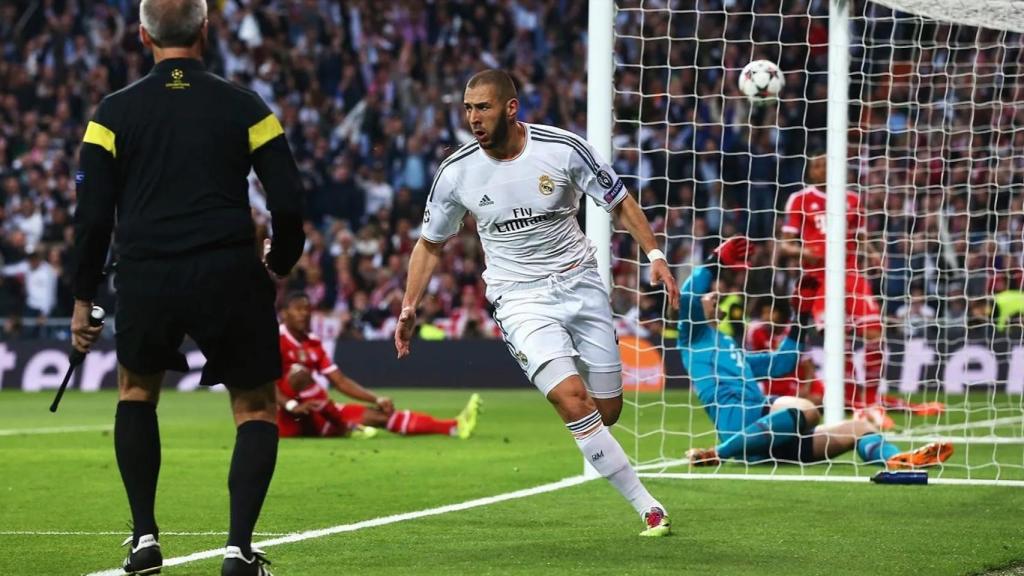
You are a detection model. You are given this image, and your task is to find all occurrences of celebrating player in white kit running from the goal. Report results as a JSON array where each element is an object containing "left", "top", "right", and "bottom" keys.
[{"left": 394, "top": 70, "right": 679, "bottom": 536}]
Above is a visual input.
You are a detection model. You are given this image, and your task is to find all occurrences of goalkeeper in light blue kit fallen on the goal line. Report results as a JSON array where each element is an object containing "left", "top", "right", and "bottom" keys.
[{"left": 679, "top": 237, "right": 953, "bottom": 468}]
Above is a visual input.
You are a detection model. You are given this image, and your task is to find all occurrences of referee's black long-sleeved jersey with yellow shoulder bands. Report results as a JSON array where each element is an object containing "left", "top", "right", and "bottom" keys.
[{"left": 74, "top": 58, "right": 304, "bottom": 300}]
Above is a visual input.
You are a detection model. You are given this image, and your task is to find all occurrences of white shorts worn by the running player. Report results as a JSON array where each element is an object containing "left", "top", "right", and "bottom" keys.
[{"left": 494, "top": 266, "right": 623, "bottom": 398}]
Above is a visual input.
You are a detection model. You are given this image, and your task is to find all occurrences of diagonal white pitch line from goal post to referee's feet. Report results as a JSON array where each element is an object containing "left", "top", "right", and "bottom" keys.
[{"left": 86, "top": 476, "right": 593, "bottom": 576}]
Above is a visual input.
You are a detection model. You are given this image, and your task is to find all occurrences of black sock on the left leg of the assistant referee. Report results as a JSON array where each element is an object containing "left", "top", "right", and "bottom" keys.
[{"left": 114, "top": 400, "right": 160, "bottom": 545}]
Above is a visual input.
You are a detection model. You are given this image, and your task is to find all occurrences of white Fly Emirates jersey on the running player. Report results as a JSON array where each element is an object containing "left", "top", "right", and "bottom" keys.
[{"left": 421, "top": 123, "right": 627, "bottom": 292}]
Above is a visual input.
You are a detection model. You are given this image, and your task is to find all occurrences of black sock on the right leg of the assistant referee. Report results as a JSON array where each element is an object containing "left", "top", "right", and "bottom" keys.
[{"left": 227, "top": 420, "right": 278, "bottom": 558}]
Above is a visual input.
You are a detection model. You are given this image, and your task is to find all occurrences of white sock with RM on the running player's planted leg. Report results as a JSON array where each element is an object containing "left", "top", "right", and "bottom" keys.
[{"left": 565, "top": 410, "right": 665, "bottom": 517}]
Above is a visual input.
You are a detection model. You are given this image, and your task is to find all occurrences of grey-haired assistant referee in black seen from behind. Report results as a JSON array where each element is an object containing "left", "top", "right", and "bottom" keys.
[{"left": 72, "top": 0, "right": 305, "bottom": 576}]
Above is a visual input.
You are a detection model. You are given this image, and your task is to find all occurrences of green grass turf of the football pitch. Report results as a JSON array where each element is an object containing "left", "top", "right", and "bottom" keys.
[{"left": 0, "top": 389, "right": 1024, "bottom": 576}]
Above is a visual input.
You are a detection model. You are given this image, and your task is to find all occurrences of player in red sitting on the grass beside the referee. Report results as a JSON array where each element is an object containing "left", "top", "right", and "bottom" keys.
[{"left": 278, "top": 292, "right": 480, "bottom": 439}]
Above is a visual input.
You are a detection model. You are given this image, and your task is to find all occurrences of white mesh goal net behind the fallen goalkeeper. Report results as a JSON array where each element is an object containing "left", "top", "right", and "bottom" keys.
[{"left": 602, "top": 0, "right": 1024, "bottom": 482}]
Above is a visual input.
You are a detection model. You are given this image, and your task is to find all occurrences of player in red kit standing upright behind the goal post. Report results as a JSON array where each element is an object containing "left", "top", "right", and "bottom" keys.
[{"left": 779, "top": 155, "right": 936, "bottom": 428}]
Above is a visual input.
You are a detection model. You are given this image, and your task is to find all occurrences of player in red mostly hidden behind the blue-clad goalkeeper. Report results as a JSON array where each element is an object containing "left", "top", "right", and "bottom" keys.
[{"left": 743, "top": 301, "right": 824, "bottom": 406}]
